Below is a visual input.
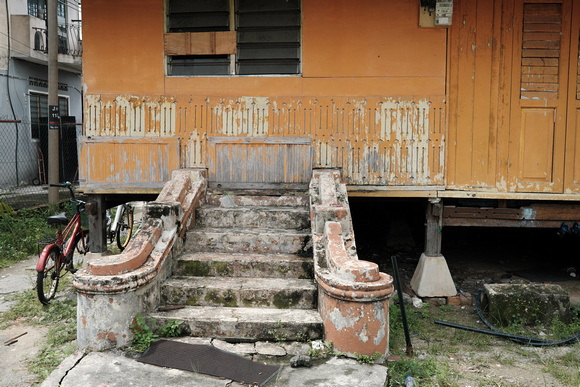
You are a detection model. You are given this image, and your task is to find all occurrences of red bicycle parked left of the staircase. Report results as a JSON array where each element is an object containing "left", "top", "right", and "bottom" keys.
[{"left": 36, "top": 181, "right": 89, "bottom": 304}]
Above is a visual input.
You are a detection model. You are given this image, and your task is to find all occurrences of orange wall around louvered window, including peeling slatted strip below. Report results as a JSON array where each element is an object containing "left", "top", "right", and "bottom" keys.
[{"left": 79, "top": 0, "right": 447, "bottom": 192}]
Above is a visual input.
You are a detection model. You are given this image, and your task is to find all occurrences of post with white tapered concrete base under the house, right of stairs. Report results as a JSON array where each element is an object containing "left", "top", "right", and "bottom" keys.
[{"left": 411, "top": 198, "right": 457, "bottom": 297}]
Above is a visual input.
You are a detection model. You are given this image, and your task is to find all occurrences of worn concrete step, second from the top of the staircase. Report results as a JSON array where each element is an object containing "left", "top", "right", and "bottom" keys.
[{"left": 196, "top": 205, "right": 310, "bottom": 230}]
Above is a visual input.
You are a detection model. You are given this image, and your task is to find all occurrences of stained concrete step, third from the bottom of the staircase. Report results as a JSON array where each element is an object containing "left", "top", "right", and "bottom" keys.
[{"left": 174, "top": 252, "right": 314, "bottom": 279}]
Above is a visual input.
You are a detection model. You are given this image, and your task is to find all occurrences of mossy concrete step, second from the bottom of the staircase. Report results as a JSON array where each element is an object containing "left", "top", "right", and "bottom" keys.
[{"left": 161, "top": 277, "right": 317, "bottom": 309}]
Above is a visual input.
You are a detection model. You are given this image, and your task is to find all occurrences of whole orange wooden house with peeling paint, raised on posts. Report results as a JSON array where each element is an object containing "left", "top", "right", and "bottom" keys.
[{"left": 79, "top": 0, "right": 580, "bottom": 278}]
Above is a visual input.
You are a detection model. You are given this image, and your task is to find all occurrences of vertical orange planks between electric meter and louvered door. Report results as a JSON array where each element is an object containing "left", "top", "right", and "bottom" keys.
[{"left": 447, "top": 0, "right": 510, "bottom": 189}]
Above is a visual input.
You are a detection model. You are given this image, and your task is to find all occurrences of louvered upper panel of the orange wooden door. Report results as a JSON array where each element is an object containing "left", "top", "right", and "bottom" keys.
[{"left": 520, "top": 3, "right": 562, "bottom": 100}]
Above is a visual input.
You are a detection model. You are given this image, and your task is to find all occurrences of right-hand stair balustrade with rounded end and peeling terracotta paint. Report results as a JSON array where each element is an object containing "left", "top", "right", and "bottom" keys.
[{"left": 310, "top": 170, "right": 393, "bottom": 355}]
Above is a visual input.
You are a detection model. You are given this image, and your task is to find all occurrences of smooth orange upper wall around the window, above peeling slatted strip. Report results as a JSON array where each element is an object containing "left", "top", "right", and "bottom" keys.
[{"left": 83, "top": 0, "right": 447, "bottom": 96}]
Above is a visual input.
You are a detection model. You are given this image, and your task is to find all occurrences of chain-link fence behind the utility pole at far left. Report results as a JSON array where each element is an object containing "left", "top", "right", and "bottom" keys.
[{"left": 0, "top": 119, "right": 81, "bottom": 210}]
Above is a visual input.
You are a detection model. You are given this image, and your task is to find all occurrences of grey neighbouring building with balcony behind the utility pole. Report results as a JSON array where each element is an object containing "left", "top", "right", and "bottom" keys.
[{"left": 0, "top": 0, "right": 83, "bottom": 188}]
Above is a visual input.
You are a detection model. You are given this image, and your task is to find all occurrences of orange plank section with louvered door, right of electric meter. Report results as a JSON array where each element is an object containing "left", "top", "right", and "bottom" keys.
[{"left": 448, "top": 0, "right": 580, "bottom": 193}]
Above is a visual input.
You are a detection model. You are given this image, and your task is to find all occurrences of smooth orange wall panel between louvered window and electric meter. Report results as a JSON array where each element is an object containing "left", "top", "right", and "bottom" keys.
[{"left": 303, "top": 0, "right": 446, "bottom": 79}]
